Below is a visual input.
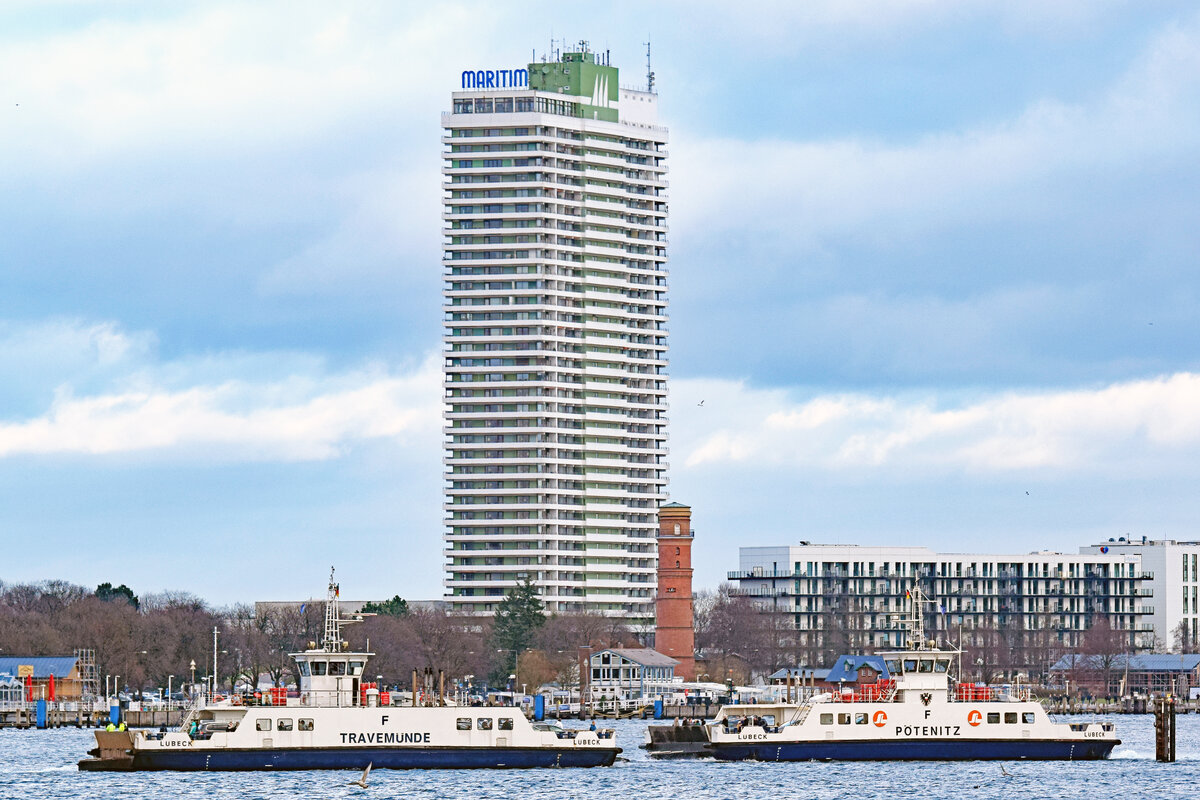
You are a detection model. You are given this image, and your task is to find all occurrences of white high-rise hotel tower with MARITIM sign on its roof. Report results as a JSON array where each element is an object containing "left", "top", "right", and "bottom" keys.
[{"left": 442, "top": 47, "right": 667, "bottom": 631}]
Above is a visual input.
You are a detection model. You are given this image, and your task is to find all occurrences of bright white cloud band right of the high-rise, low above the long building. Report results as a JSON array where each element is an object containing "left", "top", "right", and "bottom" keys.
[{"left": 673, "top": 373, "right": 1200, "bottom": 474}]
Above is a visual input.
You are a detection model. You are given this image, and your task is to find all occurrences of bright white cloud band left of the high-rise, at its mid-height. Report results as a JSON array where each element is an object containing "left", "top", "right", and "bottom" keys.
[{"left": 0, "top": 323, "right": 442, "bottom": 462}]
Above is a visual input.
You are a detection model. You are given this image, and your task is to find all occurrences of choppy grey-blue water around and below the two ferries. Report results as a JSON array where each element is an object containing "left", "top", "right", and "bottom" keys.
[{"left": 0, "top": 715, "right": 1200, "bottom": 800}]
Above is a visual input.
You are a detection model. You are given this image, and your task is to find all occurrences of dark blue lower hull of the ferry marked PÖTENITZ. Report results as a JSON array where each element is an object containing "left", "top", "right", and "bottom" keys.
[{"left": 707, "top": 739, "right": 1121, "bottom": 762}]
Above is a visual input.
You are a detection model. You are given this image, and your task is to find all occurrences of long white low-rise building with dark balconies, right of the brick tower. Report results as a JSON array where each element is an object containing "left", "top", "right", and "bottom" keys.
[{"left": 728, "top": 543, "right": 1154, "bottom": 678}]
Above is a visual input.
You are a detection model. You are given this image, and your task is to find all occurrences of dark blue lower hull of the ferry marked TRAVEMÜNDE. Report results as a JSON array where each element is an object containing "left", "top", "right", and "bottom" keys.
[{"left": 79, "top": 747, "right": 620, "bottom": 771}]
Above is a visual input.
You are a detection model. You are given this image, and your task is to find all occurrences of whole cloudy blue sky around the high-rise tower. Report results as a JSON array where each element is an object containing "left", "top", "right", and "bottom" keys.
[{"left": 0, "top": 0, "right": 1200, "bottom": 603}]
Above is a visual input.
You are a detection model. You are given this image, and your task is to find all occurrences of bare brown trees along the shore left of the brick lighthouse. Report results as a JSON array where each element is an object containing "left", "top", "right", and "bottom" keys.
[{"left": 0, "top": 581, "right": 636, "bottom": 691}]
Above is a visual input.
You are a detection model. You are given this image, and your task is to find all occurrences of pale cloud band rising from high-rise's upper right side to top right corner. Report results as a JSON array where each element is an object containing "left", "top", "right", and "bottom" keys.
[{"left": 672, "top": 9, "right": 1200, "bottom": 247}]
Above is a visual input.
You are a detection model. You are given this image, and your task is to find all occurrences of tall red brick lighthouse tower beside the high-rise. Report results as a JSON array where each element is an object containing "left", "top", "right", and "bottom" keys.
[{"left": 654, "top": 503, "right": 696, "bottom": 680}]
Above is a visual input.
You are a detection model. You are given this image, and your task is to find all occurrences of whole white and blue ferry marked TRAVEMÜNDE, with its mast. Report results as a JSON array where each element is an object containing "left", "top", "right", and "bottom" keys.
[{"left": 79, "top": 575, "right": 620, "bottom": 770}]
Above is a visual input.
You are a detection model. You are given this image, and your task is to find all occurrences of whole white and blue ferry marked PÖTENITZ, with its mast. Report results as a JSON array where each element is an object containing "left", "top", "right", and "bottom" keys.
[{"left": 646, "top": 591, "right": 1121, "bottom": 762}]
